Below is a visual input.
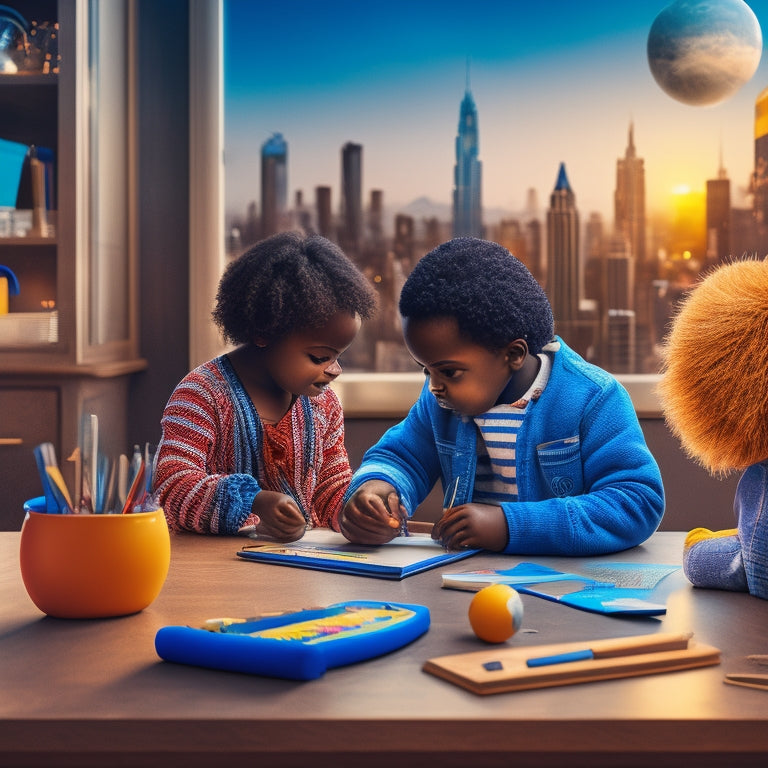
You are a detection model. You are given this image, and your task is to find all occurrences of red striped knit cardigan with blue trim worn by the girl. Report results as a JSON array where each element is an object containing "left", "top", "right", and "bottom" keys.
[{"left": 154, "top": 355, "right": 351, "bottom": 534}]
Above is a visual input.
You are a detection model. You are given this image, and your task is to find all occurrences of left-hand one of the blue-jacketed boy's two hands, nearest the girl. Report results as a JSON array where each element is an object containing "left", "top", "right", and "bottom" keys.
[{"left": 339, "top": 480, "right": 408, "bottom": 544}]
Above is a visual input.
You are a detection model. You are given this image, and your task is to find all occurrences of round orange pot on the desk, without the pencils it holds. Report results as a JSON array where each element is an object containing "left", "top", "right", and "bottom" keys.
[{"left": 19, "top": 499, "right": 171, "bottom": 619}]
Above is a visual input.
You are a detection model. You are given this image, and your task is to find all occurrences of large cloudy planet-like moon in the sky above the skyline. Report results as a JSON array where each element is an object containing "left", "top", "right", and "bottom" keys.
[{"left": 648, "top": 0, "right": 763, "bottom": 106}]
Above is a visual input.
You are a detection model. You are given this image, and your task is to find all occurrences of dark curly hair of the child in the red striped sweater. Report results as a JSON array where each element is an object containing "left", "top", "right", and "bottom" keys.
[{"left": 213, "top": 232, "right": 376, "bottom": 344}]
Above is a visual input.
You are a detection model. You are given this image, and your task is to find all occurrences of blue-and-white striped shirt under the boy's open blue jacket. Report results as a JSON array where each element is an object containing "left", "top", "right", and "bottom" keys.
[{"left": 472, "top": 353, "right": 552, "bottom": 505}]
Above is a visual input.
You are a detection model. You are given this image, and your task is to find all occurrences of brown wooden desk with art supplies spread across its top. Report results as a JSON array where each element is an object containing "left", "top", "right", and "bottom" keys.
[{"left": 0, "top": 533, "right": 768, "bottom": 768}]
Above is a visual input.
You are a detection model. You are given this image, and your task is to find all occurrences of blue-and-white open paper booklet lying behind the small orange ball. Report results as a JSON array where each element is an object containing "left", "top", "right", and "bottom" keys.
[{"left": 442, "top": 562, "right": 680, "bottom": 616}]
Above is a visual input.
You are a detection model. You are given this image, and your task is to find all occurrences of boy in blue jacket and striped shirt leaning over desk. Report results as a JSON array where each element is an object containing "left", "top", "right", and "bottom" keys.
[{"left": 339, "top": 238, "right": 664, "bottom": 556}]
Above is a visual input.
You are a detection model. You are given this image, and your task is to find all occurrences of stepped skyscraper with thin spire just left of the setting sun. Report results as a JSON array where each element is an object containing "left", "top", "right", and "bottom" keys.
[{"left": 613, "top": 123, "right": 646, "bottom": 264}]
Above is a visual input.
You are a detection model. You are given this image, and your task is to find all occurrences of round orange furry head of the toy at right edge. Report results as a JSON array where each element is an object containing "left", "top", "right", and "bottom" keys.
[{"left": 658, "top": 260, "right": 768, "bottom": 475}]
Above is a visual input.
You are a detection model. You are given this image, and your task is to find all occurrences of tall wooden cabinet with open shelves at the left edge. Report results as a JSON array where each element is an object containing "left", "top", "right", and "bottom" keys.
[{"left": 0, "top": 0, "right": 146, "bottom": 530}]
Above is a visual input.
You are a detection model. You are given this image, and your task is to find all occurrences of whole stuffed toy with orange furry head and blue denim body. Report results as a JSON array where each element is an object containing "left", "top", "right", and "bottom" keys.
[{"left": 658, "top": 259, "right": 768, "bottom": 599}]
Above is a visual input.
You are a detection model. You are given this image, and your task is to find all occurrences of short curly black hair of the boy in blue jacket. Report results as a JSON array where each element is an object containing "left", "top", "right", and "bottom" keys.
[{"left": 400, "top": 237, "right": 554, "bottom": 354}]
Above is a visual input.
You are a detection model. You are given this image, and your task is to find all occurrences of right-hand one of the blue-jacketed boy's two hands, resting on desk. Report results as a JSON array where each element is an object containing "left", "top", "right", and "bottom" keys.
[{"left": 432, "top": 504, "right": 507, "bottom": 552}]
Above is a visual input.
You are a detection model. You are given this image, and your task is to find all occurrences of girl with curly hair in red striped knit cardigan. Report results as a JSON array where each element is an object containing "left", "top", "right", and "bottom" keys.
[{"left": 155, "top": 232, "right": 376, "bottom": 541}]
